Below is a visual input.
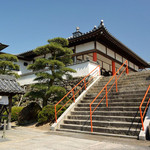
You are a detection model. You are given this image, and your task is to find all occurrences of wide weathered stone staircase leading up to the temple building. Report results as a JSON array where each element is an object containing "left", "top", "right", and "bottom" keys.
[{"left": 57, "top": 71, "right": 150, "bottom": 138}]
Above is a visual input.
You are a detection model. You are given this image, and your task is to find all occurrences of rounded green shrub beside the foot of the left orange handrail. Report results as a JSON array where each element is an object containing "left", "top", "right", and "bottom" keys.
[{"left": 38, "top": 105, "right": 66, "bottom": 124}]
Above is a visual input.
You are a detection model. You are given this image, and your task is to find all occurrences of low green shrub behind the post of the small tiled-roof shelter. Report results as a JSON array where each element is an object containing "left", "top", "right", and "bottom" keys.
[{"left": 3, "top": 106, "right": 23, "bottom": 122}]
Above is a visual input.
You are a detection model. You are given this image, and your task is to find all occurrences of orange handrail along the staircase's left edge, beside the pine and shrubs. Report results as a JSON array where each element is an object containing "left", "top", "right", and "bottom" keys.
[{"left": 54, "top": 65, "right": 100, "bottom": 123}]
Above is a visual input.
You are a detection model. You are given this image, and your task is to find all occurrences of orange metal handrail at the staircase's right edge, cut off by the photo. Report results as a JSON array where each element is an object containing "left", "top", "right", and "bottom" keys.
[{"left": 139, "top": 85, "right": 150, "bottom": 131}]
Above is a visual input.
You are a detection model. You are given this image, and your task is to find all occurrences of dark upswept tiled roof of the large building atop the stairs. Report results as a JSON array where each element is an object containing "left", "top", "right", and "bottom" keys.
[{"left": 68, "top": 22, "right": 149, "bottom": 67}]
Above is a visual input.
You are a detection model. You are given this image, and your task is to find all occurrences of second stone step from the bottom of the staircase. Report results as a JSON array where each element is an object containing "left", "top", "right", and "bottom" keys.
[{"left": 64, "top": 119, "right": 142, "bottom": 129}]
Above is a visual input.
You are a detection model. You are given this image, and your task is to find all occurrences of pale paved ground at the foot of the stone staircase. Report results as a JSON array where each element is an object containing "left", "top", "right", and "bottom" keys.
[{"left": 0, "top": 127, "right": 150, "bottom": 150}]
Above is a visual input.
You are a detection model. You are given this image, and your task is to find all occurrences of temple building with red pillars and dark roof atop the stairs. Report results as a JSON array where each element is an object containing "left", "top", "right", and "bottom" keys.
[{"left": 69, "top": 20, "right": 149, "bottom": 74}]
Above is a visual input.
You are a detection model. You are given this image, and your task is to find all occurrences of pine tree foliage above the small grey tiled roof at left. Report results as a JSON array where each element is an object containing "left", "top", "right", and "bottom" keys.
[{"left": 0, "top": 54, "right": 19, "bottom": 78}]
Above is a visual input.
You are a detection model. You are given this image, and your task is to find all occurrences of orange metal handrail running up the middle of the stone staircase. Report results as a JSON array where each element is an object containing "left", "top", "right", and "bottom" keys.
[{"left": 90, "top": 60, "right": 129, "bottom": 132}]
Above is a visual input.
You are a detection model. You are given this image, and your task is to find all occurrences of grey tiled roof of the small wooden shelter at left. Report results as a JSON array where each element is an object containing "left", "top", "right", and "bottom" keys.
[{"left": 0, "top": 75, "right": 25, "bottom": 95}]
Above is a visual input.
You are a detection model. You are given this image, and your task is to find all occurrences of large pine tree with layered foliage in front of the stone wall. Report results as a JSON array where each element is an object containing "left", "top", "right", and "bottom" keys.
[{"left": 26, "top": 37, "right": 75, "bottom": 107}]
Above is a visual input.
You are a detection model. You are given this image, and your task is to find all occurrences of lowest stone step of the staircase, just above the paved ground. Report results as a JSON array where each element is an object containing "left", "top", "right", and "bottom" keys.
[{"left": 60, "top": 124, "right": 140, "bottom": 136}]
